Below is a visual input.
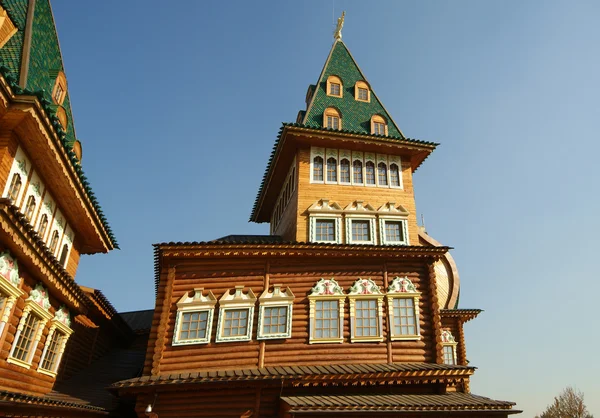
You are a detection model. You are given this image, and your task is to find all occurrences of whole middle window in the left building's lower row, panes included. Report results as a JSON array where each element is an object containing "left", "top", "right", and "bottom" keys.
[{"left": 6, "top": 284, "right": 52, "bottom": 369}]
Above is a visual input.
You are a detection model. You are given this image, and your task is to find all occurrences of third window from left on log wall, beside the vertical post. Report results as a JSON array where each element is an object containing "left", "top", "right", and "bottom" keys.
[{"left": 257, "top": 284, "right": 294, "bottom": 340}]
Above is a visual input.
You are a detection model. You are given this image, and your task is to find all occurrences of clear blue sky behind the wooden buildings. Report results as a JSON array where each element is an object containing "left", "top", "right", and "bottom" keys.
[{"left": 53, "top": 0, "right": 600, "bottom": 417}]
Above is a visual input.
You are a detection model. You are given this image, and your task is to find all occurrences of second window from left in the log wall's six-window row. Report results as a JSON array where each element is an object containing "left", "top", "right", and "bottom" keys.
[{"left": 216, "top": 286, "right": 256, "bottom": 343}]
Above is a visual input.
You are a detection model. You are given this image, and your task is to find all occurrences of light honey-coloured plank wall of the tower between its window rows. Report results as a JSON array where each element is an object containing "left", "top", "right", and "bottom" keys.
[{"left": 295, "top": 147, "right": 420, "bottom": 245}]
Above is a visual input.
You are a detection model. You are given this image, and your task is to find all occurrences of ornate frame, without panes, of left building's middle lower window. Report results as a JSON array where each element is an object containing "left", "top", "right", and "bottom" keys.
[{"left": 6, "top": 284, "right": 52, "bottom": 369}]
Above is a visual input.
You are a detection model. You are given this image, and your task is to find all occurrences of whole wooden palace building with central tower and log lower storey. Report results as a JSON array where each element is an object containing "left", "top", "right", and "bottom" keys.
[{"left": 111, "top": 16, "right": 520, "bottom": 418}]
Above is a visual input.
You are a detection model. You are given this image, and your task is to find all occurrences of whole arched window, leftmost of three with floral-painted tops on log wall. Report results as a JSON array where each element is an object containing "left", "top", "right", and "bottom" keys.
[{"left": 308, "top": 278, "right": 346, "bottom": 344}]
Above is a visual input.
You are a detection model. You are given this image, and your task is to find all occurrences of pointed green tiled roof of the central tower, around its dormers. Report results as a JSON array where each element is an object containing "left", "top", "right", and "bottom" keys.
[{"left": 303, "top": 40, "right": 404, "bottom": 138}]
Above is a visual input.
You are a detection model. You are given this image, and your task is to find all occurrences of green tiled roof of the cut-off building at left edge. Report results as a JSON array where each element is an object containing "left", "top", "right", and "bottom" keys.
[{"left": 0, "top": 0, "right": 119, "bottom": 248}]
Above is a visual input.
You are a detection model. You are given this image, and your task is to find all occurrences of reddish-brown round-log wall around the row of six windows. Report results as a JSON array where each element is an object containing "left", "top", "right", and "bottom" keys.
[{"left": 145, "top": 258, "right": 436, "bottom": 374}]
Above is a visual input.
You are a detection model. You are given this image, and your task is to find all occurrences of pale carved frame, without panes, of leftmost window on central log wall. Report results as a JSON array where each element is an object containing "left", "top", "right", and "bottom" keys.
[{"left": 171, "top": 287, "right": 217, "bottom": 346}]
